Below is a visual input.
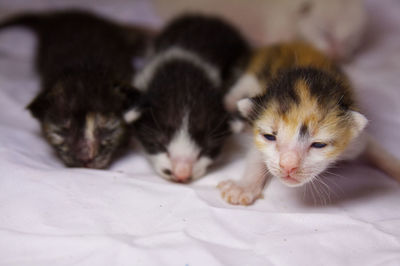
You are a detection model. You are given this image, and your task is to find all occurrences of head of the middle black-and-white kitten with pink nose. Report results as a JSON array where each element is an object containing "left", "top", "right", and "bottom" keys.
[{"left": 136, "top": 109, "right": 230, "bottom": 183}]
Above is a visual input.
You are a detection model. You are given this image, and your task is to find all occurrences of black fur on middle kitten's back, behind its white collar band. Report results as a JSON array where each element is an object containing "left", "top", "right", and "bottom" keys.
[{"left": 154, "top": 15, "right": 250, "bottom": 85}]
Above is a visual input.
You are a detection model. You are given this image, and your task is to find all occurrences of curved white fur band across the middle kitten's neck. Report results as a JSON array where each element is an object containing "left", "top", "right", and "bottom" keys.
[{"left": 134, "top": 47, "right": 221, "bottom": 91}]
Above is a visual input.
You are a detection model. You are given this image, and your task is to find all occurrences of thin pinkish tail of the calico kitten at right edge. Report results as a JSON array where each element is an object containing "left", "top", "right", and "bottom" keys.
[{"left": 364, "top": 136, "right": 400, "bottom": 182}]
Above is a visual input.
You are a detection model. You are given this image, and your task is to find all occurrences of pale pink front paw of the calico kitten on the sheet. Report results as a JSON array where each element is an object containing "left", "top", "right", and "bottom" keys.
[{"left": 217, "top": 180, "right": 262, "bottom": 205}]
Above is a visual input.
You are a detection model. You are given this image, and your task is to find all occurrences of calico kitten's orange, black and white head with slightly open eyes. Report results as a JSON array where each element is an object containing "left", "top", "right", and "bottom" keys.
[{"left": 238, "top": 69, "right": 367, "bottom": 187}]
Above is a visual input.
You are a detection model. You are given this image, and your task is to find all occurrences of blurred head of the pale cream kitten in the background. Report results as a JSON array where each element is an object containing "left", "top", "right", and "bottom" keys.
[{"left": 296, "top": 0, "right": 366, "bottom": 60}]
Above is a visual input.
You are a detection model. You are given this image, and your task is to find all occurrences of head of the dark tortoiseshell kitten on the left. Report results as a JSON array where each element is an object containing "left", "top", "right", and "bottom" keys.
[{"left": 28, "top": 80, "right": 139, "bottom": 168}]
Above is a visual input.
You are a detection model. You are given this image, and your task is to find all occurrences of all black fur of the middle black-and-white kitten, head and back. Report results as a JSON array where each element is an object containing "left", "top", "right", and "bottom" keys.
[{"left": 135, "top": 15, "right": 249, "bottom": 158}]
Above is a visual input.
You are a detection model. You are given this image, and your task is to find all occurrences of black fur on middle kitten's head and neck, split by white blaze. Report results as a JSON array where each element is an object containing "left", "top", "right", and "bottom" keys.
[{"left": 135, "top": 60, "right": 230, "bottom": 158}]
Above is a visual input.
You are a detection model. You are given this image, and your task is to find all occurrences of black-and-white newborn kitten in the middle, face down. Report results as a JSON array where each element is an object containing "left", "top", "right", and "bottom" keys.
[{"left": 127, "top": 15, "right": 249, "bottom": 183}]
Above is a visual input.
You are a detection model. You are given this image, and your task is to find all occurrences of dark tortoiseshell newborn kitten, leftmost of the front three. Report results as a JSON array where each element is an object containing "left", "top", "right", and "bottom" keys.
[{"left": 0, "top": 10, "right": 145, "bottom": 168}]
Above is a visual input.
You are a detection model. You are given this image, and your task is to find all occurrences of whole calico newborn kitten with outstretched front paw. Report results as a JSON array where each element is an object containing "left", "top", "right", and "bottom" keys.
[{"left": 219, "top": 43, "right": 400, "bottom": 205}]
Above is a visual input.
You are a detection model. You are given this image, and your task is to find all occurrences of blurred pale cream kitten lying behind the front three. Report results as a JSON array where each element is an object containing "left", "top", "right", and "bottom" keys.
[{"left": 153, "top": 0, "right": 367, "bottom": 60}]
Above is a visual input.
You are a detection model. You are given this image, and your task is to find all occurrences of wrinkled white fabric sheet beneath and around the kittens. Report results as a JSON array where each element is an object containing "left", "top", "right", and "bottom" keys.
[{"left": 0, "top": 0, "right": 400, "bottom": 266}]
